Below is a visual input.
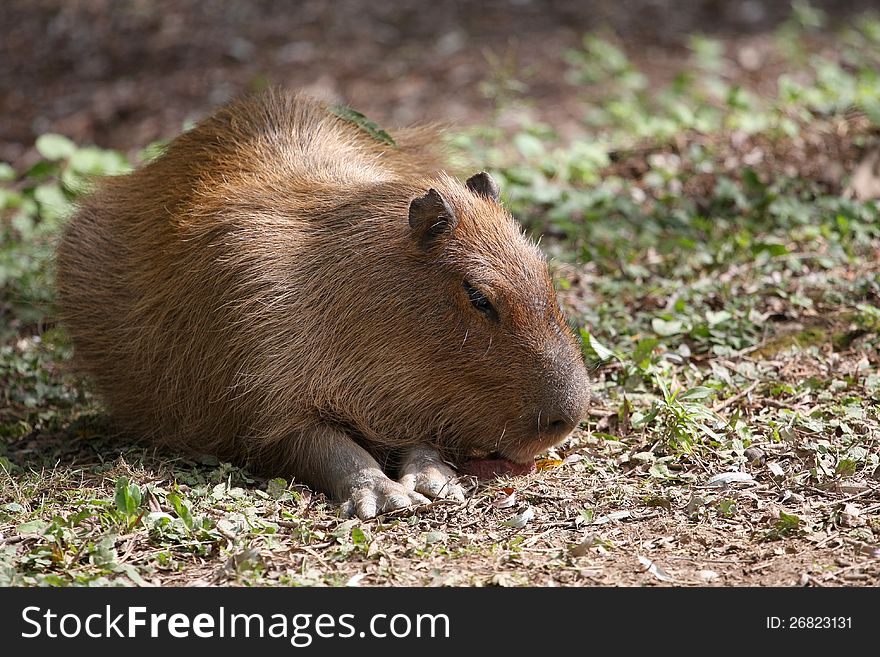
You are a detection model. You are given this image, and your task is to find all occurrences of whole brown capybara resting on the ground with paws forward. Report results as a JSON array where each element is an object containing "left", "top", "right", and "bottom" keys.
[{"left": 57, "top": 90, "right": 589, "bottom": 518}]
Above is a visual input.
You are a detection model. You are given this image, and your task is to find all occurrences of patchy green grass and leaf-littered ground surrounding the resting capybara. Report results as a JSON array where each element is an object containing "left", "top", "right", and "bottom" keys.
[{"left": 0, "top": 4, "right": 880, "bottom": 585}]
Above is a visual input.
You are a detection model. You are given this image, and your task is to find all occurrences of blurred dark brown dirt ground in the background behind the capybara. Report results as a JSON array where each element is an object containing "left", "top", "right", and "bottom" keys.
[{"left": 0, "top": 0, "right": 876, "bottom": 163}]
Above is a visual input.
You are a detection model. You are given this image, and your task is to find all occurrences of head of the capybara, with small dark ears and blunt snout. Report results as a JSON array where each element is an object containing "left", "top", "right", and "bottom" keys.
[{"left": 344, "top": 173, "right": 589, "bottom": 462}]
